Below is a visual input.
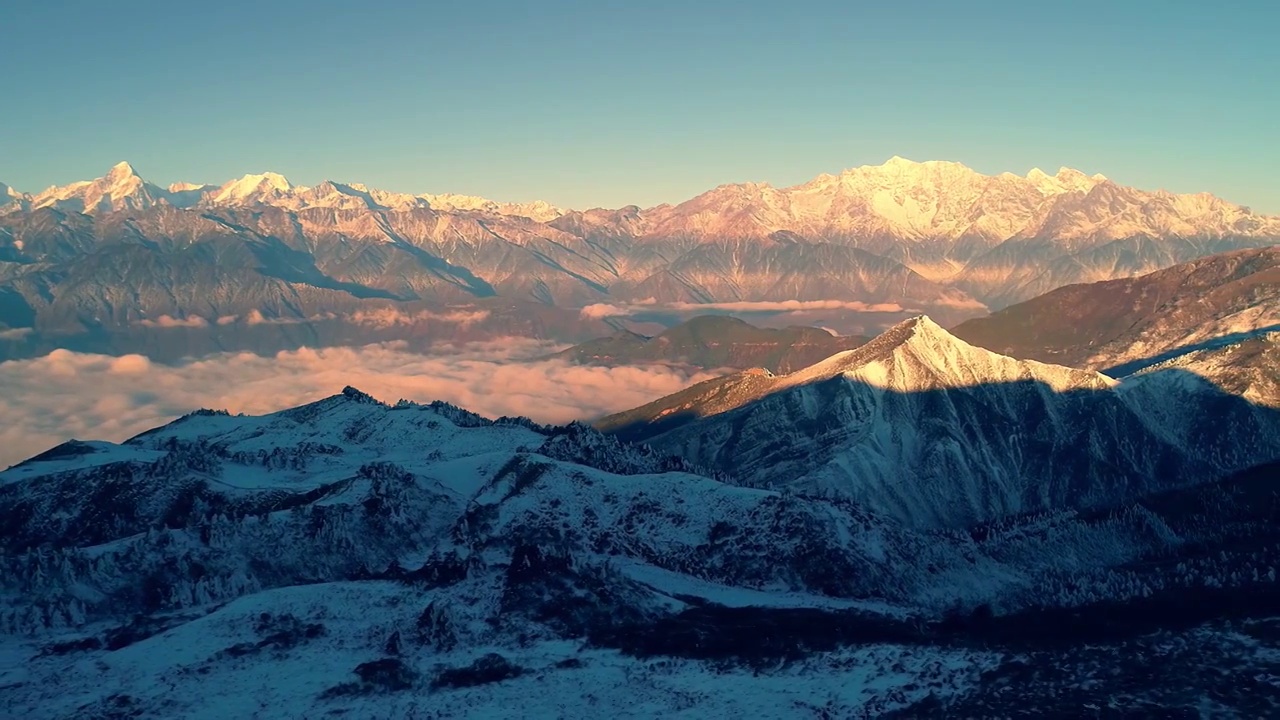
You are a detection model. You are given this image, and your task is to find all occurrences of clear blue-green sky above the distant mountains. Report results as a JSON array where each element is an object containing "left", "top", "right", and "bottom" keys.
[{"left": 0, "top": 0, "right": 1280, "bottom": 214}]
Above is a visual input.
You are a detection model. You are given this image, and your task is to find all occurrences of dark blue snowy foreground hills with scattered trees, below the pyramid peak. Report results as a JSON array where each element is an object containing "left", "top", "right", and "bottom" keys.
[{"left": 0, "top": 379, "right": 1280, "bottom": 717}]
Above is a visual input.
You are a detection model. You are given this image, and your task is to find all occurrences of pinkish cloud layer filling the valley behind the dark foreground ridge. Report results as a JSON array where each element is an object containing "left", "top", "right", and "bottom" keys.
[{"left": 0, "top": 340, "right": 713, "bottom": 469}]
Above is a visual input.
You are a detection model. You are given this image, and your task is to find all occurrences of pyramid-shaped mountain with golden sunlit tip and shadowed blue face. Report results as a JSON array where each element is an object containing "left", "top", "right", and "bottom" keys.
[{"left": 596, "top": 316, "right": 1280, "bottom": 528}]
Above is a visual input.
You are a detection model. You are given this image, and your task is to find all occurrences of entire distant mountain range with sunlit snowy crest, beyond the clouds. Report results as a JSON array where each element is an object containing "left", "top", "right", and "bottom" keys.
[{"left": 0, "top": 158, "right": 1280, "bottom": 356}]
